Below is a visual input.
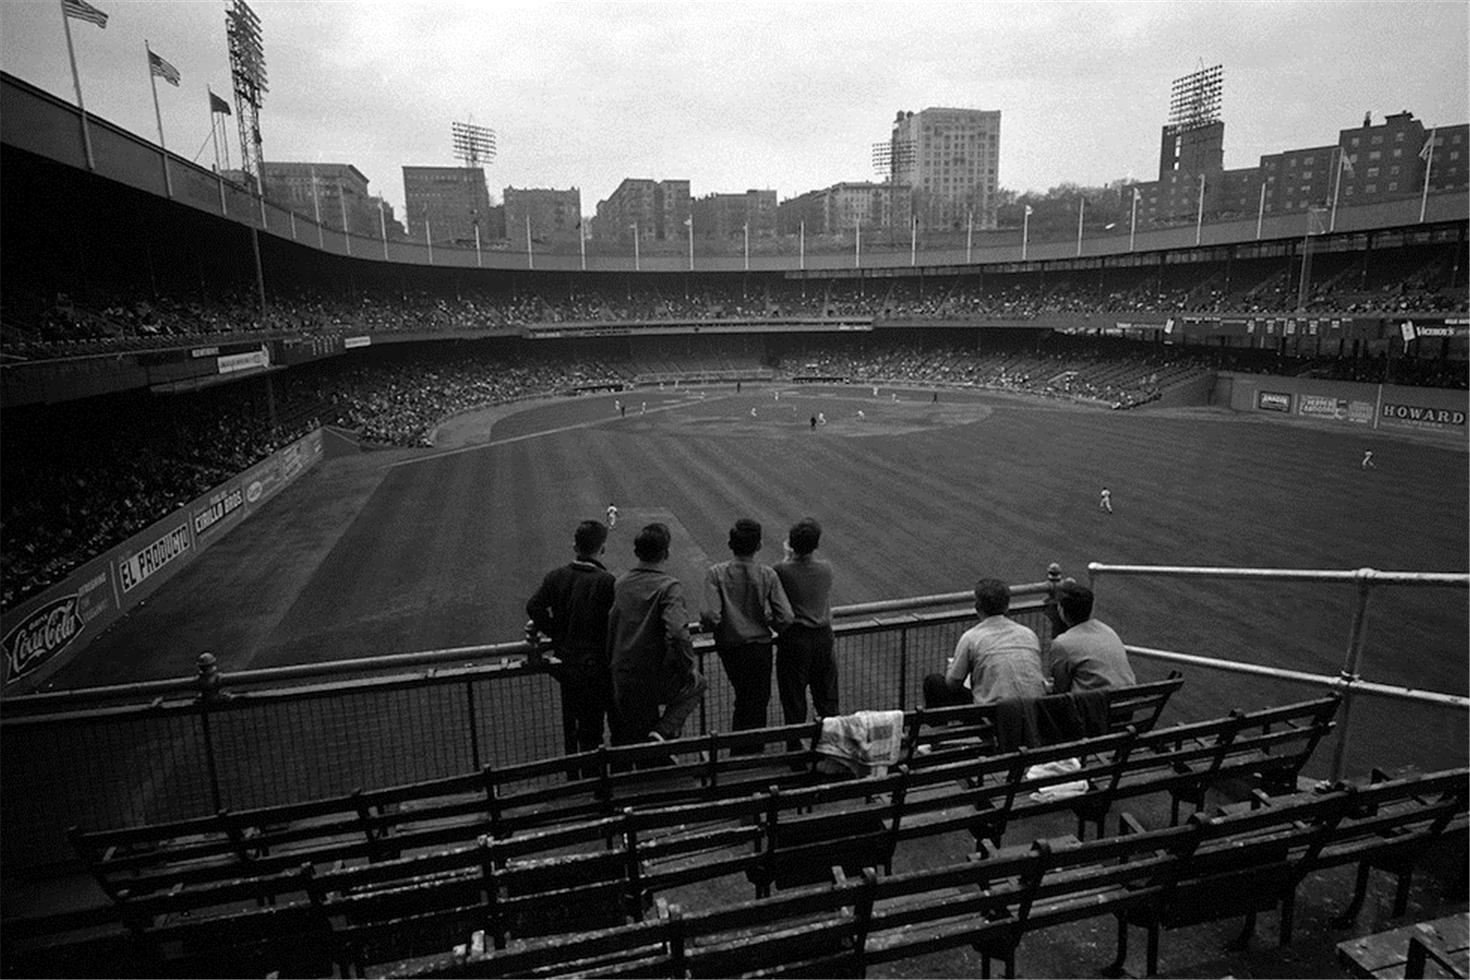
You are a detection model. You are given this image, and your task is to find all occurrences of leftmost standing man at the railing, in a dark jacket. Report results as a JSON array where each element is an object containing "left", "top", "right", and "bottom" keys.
[{"left": 526, "top": 520, "right": 613, "bottom": 752}]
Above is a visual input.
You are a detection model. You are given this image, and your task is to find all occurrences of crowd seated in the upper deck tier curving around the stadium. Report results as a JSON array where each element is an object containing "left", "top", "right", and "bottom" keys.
[{"left": 0, "top": 250, "right": 1467, "bottom": 359}]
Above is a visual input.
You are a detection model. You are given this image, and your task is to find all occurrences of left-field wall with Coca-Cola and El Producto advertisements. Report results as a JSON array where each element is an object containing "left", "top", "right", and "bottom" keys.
[{"left": 0, "top": 429, "right": 322, "bottom": 695}]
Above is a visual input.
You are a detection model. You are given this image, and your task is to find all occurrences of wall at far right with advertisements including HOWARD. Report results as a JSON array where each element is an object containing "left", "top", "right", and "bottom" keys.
[{"left": 1213, "top": 372, "right": 1470, "bottom": 441}]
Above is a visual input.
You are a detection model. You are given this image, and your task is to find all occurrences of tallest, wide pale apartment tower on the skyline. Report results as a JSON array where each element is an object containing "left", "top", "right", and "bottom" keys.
[{"left": 891, "top": 109, "right": 1001, "bottom": 228}]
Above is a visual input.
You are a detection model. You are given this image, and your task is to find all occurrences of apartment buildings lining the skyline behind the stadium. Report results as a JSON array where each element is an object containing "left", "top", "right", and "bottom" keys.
[{"left": 263, "top": 78, "right": 1470, "bottom": 248}]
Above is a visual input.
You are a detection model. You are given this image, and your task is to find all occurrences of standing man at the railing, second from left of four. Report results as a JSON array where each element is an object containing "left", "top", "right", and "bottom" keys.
[{"left": 607, "top": 523, "right": 704, "bottom": 745}]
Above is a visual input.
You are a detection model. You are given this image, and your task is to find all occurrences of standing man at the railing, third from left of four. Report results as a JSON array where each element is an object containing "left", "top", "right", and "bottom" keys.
[{"left": 700, "top": 517, "right": 792, "bottom": 746}]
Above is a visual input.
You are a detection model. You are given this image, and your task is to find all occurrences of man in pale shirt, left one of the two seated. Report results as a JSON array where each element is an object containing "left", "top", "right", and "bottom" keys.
[{"left": 923, "top": 579, "right": 1047, "bottom": 708}]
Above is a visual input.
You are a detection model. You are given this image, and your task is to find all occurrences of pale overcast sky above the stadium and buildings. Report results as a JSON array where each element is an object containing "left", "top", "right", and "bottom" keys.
[{"left": 0, "top": 0, "right": 1470, "bottom": 216}]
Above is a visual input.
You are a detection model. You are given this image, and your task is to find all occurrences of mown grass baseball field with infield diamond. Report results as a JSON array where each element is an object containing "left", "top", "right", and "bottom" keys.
[{"left": 54, "top": 385, "right": 1470, "bottom": 765}]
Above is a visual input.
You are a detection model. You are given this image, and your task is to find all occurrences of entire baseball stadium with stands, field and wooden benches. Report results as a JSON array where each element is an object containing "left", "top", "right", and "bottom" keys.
[{"left": 0, "top": 28, "right": 1470, "bottom": 977}]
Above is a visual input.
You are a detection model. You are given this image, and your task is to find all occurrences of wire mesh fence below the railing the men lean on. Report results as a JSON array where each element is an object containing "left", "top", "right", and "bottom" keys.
[{"left": 0, "top": 599, "right": 1051, "bottom": 871}]
